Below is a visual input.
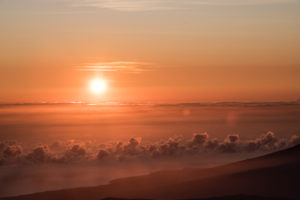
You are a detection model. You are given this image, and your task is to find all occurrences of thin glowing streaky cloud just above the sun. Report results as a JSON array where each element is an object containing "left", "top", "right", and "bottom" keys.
[{"left": 75, "top": 61, "right": 152, "bottom": 73}]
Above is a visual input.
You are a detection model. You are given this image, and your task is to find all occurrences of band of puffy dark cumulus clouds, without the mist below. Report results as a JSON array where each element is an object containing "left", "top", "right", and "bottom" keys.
[{"left": 0, "top": 132, "right": 300, "bottom": 165}]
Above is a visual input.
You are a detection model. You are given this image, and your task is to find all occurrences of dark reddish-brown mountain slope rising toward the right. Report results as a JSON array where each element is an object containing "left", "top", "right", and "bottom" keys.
[{"left": 2, "top": 145, "right": 300, "bottom": 200}]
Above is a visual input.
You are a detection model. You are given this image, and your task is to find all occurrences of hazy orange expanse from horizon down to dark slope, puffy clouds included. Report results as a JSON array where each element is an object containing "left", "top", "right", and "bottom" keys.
[{"left": 0, "top": 102, "right": 300, "bottom": 196}]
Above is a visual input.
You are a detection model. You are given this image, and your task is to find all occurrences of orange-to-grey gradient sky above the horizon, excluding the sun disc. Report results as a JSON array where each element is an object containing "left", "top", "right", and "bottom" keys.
[{"left": 0, "top": 0, "right": 300, "bottom": 102}]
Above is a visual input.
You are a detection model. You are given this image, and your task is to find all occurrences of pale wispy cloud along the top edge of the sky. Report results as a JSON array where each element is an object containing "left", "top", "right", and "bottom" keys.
[{"left": 73, "top": 0, "right": 297, "bottom": 11}]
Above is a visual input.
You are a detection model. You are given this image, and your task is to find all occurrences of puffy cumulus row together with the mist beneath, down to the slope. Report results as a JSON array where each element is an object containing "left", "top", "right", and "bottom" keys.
[{"left": 0, "top": 131, "right": 300, "bottom": 196}]
